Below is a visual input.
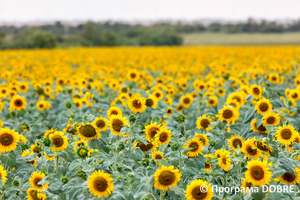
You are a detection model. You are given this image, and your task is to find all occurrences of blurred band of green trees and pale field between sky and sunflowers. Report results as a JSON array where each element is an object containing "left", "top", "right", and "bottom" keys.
[{"left": 0, "top": 19, "right": 300, "bottom": 49}]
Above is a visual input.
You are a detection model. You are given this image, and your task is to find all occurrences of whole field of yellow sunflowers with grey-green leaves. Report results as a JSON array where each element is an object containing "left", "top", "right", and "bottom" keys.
[{"left": 0, "top": 47, "right": 300, "bottom": 200}]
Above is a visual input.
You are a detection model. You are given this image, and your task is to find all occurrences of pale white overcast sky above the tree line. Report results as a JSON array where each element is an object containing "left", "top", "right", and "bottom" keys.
[{"left": 0, "top": 0, "right": 300, "bottom": 22}]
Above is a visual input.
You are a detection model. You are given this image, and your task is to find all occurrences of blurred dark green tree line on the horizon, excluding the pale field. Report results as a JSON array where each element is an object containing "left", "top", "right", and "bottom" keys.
[{"left": 0, "top": 19, "right": 300, "bottom": 49}]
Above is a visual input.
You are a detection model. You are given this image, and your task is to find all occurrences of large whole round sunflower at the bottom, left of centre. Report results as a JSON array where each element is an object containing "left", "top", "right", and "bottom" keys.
[{"left": 87, "top": 170, "right": 114, "bottom": 198}]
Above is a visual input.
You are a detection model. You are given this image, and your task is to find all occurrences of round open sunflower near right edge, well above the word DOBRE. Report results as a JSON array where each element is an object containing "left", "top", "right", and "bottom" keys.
[{"left": 276, "top": 124, "right": 298, "bottom": 145}]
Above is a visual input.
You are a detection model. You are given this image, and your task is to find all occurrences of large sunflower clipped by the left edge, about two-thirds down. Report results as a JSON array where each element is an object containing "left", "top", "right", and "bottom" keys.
[{"left": 0, "top": 128, "right": 20, "bottom": 153}]
